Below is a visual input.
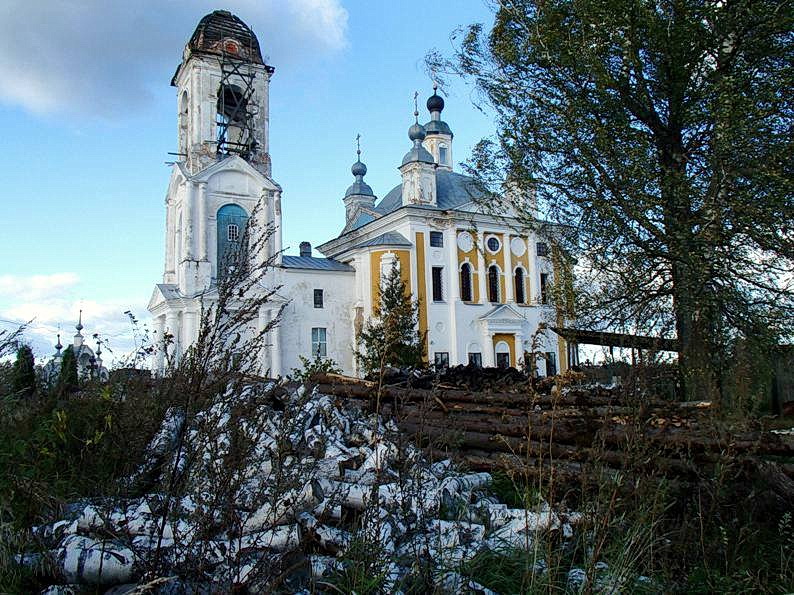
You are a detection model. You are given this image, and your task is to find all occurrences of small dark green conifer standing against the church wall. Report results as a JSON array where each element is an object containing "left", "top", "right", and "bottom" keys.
[{"left": 356, "top": 262, "right": 424, "bottom": 375}]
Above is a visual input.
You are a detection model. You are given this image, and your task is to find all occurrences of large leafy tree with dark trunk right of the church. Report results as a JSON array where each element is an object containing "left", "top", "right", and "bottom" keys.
[{"left": 431, "top": 0, "right": 794, "bottom": 397}]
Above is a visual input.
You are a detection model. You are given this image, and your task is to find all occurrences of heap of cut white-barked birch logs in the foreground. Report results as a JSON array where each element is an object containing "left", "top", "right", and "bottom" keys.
[{"left": 17, "top": 382, "right": 585, "bottom": 595}]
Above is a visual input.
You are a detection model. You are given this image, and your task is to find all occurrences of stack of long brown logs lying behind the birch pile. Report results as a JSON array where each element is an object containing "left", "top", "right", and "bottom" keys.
[{"left": 315, "top": 374, "right": 794, "bottom": 498}]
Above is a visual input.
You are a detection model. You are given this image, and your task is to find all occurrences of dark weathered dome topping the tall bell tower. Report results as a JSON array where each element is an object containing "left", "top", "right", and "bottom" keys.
[{"left": 187, "top": 10, "right": 265, "bottom": 64}]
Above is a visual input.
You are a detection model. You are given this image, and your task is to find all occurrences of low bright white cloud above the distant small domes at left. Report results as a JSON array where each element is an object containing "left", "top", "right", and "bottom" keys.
[{"left": 0, "top": 273, "right": 145, "bottom": 362}]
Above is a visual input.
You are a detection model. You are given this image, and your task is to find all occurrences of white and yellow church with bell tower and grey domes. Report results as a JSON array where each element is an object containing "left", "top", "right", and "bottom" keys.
[{"left": 149, "top": 11, "right": 569, "bottom": 376}]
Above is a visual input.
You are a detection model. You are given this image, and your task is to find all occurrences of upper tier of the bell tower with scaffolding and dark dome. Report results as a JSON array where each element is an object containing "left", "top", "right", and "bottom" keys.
[{"left": 171, "top": 10, "right": 274, "bottom": 176}]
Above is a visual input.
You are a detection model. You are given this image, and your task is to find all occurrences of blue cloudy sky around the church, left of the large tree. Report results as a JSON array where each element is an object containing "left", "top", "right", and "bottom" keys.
[{"left": 0, "top": 0, "right": 494, "bottom": 361}]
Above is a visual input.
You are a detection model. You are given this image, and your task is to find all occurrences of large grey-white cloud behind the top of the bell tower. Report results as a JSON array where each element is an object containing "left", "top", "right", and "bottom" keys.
[{"left": 0, "top": 0, "right": 348, "bottom": 117}]
